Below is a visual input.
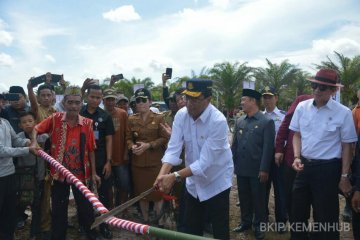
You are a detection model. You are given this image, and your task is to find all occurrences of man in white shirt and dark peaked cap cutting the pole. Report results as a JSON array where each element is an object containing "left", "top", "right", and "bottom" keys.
[{"left": 154, "top": 79, "right": 234, "bottom": 239}]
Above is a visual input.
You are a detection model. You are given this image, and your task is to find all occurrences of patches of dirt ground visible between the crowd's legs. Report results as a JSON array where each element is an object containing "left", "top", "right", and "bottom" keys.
[{"left": 16, "top": 177, "right": 353, "bottom": 240}]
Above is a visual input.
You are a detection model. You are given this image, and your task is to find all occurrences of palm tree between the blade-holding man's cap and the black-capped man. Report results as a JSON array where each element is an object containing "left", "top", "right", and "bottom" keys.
[{"left": 208, "top": 62, "right": 252, "bottom": 115}]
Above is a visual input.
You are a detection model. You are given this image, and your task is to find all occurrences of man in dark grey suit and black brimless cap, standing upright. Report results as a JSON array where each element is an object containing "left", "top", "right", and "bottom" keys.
[{"left": 231, "top": 89, "right": 275, "bottom": 239}]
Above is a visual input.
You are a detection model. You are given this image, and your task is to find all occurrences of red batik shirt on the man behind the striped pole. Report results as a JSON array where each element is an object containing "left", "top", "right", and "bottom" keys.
[{"left": 35, "top": 112, "right": 96, "bottom": 184}]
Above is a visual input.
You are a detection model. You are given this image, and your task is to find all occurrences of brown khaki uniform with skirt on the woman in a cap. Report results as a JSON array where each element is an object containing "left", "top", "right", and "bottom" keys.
[{"left": 126, "top": 112, "right": 168, "bottom": 201}]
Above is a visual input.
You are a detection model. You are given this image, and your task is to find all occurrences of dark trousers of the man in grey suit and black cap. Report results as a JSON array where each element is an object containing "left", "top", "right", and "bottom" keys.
[{"left": 237, "top": 175, "right": 266, "bottom": 228}]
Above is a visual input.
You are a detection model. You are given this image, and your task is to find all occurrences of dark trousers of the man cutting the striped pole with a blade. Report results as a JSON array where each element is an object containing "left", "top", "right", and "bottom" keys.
[{"left": 185, "top": 188, "right": 230, "bottom": 239}]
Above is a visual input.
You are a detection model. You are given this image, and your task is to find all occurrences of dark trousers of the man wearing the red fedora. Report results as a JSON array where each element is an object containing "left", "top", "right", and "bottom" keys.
[{"left": 291, "top": 161, "right": 341, "bottom": 240}]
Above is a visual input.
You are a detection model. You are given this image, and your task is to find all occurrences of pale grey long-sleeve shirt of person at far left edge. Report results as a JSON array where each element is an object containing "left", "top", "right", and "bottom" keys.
[{"left": 0, "top": 118, "right": 30, "bottom": 177}]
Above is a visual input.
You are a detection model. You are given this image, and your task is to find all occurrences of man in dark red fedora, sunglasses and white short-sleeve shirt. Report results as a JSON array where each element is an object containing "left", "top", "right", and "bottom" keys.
[{"left": 289, "top": 69, "right": 357, "bottom": 240}]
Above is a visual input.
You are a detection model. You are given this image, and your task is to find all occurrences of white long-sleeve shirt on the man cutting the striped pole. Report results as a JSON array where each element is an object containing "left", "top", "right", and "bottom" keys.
[{"left": 162, "top": 104, "right": 234, "bottom": 202}]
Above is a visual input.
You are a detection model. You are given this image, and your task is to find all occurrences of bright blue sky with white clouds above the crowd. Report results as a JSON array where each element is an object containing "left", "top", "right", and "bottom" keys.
[{"left": 0, "top": 0, "right": 360, "bottom": 92}]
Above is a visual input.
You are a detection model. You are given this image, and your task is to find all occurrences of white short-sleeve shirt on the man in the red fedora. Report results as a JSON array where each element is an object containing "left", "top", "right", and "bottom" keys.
[{"left": 289, "top": 98, "right": 357, "bottom": 160}]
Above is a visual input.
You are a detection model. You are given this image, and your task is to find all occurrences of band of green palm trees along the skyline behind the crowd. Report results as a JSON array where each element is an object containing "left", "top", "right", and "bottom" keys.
[{"left": 93, "top": 52, "right": 360, "bottom": 111}]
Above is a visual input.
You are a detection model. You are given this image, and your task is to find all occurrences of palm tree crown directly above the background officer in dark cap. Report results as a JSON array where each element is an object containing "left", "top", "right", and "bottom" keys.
[{"left": 254, "top": 59, "right": 300, "bottom": 96}]
